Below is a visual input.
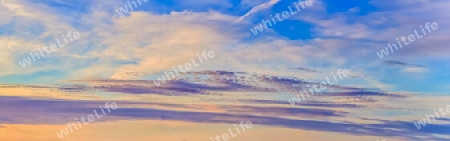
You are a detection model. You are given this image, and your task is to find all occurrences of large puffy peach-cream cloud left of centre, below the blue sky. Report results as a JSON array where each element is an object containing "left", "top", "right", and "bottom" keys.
[{"left": 71, "top": 11, "right": 239, "bottom": 79}]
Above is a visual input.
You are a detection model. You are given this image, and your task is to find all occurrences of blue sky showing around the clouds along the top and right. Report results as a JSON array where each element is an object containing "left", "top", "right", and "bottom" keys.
[{"left": 0, "top": 0, "right": 449, "bottom": 92}]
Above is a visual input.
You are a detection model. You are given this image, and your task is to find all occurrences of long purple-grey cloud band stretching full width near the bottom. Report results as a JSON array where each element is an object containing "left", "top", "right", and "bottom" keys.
[{"left": 0, "top": 94, "right": 450, "bottom": 140}]
